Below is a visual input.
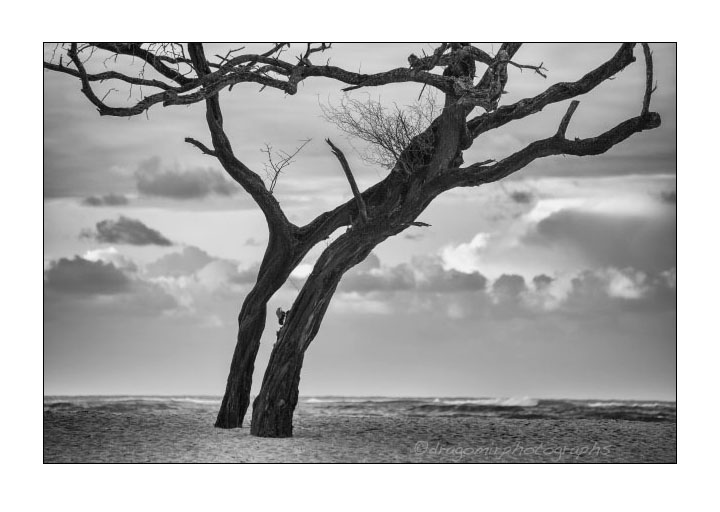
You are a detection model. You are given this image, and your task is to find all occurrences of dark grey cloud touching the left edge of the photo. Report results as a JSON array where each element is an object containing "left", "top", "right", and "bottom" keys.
[{"left": 44, "top": 256, "right": 131, "bottom": 295}]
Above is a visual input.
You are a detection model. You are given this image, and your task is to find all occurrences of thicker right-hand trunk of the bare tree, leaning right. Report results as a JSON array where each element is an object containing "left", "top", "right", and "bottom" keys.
[{"left": 250, "top": 98, "right": 467, "bottom": 437}]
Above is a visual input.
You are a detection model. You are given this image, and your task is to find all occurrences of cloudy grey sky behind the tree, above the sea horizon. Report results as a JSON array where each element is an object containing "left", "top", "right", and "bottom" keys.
[{"left": 43, "top": 44, "right": 677, "bottom": 399}]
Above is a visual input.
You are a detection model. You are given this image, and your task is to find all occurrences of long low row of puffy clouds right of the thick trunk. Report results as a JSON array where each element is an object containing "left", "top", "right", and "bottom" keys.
[{"left": 335, "top": 249, "right": 675, "bottom": 319}]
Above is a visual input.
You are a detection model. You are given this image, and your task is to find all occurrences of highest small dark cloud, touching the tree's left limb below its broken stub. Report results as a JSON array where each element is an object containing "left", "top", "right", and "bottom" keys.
[{"left": 135, "top": 158, "right": 239, "bottom": 200}]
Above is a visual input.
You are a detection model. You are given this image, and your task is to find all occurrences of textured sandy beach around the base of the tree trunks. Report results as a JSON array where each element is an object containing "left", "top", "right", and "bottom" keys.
[{"left": 44, "top": 396, "right": 677, "bottom": 463}]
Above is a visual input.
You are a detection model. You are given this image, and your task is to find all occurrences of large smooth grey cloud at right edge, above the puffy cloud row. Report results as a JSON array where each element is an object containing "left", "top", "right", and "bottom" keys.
[{"left": 524, "top": 210, "right": 677, "bottom": 272}]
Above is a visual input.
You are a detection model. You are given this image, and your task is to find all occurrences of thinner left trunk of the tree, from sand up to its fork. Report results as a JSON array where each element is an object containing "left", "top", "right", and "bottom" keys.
[{"left": 215, "top": 235, "right": 301, "bottom": 428}]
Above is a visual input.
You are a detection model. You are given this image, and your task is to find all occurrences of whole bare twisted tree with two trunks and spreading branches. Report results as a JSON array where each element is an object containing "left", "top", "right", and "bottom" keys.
[{"left": 44, "top": 43, "right": 660, "bottom": 437}]
